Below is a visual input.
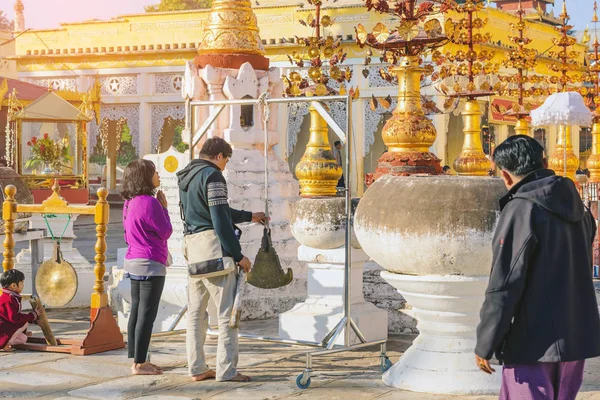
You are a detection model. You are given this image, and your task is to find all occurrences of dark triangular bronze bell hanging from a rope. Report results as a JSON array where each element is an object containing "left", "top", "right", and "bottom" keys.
[{"left": 246, "top": 227, "right": 294, "bottom": 289}]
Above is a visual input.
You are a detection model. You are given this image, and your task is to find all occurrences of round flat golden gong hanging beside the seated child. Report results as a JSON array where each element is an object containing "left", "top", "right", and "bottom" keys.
[{"left": 35, "top": 259, "right": 77, "bottom": 307}]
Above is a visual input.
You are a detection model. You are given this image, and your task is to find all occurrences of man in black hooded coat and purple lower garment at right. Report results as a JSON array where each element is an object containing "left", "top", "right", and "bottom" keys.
[{"left": 475, "top": 135, "right": 600, "bottom": 400}]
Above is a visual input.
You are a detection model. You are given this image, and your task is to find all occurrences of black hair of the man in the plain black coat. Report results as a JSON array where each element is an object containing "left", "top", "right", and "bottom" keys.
[{"left": 492, "top": 135, "right": 545, "bottom": 176}]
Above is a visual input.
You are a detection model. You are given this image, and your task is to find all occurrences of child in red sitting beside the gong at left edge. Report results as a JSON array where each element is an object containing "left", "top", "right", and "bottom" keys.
[{"left": 0, "top": 269, "right": 41, "bottom": 351}]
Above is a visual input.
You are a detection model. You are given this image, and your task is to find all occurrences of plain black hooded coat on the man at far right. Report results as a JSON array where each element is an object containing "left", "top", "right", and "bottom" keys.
[{"left": 475, "top": 169, "right": 600, "bottom": 365}]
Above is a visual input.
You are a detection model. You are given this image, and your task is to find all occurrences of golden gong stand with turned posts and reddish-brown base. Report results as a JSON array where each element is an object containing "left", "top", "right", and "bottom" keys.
[{"left": 2, "top": 179, "right": 125, "bottom": 355}]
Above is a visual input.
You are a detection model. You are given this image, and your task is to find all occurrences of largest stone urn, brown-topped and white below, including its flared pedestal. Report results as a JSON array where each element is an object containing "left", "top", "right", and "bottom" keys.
[{"left": 354, "top": 176, "right": 506, "bottom": 395}]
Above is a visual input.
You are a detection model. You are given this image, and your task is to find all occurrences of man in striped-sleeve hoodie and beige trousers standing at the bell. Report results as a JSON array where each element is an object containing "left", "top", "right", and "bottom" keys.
[{"left": 177, "top": 137, "right": 265, "bottom": 382}]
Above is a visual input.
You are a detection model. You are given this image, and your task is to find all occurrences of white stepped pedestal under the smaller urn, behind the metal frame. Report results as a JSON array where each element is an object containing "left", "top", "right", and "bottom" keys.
[{"left": 279, "top": 246, "right": 388, "bottom": 345}]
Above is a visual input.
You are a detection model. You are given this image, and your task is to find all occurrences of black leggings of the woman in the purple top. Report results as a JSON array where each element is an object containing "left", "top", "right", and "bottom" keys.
[{"left": 127, "top": 276, "right": 165, "bottom": 364}]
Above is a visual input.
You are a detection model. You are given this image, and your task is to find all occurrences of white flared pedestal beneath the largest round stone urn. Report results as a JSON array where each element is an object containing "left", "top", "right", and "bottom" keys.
[{"left": 381, "top": 272, "right": 501, "bottom": 395}]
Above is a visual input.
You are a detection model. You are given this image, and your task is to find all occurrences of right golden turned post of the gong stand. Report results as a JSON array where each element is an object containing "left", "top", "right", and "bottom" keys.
[{"left": 91, "top": 188, "right": 109, "bottom": 310}]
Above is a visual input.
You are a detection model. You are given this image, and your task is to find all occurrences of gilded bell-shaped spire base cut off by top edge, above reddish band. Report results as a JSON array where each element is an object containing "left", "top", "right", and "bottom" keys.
[{"left": 198, "top": 0, "right": 265, "bottom": 56}]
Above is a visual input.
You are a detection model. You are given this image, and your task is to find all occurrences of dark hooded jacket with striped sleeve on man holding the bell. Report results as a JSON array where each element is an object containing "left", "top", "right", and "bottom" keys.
[{"left": 177, "top": 159, "right": 252, "bottom": 262}]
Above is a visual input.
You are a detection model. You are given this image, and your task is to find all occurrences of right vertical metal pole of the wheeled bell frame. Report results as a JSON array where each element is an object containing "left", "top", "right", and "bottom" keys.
[{"left": 344, "top": 96, "right": 353, "bottom": 347}]
